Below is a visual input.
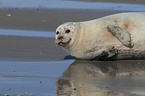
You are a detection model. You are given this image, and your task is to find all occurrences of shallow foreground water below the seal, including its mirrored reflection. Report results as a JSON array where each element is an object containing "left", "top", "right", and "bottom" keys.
[{"left": 0, "top": 60, "right": 145, "bottom": 96}]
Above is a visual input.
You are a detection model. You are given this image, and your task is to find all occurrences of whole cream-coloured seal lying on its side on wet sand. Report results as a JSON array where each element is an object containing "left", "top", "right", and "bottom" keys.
[{"left": 56, "top": 12, "right": 145, "bottom": 60}]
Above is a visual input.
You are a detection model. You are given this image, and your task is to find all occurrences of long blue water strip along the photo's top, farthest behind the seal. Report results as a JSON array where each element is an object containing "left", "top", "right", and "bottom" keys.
[{"left": 0, "top": 0, "right": 145, "bottom": 11}]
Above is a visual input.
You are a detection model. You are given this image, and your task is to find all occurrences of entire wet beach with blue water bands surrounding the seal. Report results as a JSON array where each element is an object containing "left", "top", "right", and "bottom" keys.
[{"left": 0, "top": 0, "right": 145, "bottom": 96}]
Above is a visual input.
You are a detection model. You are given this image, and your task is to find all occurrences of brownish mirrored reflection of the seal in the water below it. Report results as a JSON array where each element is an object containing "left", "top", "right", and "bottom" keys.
[{"left": 56, "top": 61, "right": 145, "bottom": 96}]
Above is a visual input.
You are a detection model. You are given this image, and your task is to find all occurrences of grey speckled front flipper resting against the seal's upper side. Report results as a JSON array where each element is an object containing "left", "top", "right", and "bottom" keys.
[{"left": 107, "top": 25, "right": 134, "bottom": 48}]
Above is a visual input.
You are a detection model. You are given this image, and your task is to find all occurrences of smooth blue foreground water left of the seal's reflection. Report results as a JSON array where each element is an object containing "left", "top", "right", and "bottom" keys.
[{"left": 0, "top": 60, "right": 73, "bottom": 96}]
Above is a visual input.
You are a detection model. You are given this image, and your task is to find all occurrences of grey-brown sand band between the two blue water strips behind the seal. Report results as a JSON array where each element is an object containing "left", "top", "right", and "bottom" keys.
[{"left": 0, "top": 8, "right": 127, "bottom": 31}]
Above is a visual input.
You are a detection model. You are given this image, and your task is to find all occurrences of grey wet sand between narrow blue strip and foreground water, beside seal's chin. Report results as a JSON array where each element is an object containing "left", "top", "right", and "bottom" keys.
[{"left": 0, "top": 36, "right": 67, "bottom": 61}]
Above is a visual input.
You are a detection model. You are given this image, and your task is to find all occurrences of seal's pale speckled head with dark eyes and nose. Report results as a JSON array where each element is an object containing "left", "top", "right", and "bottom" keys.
[{"left": 55, "top": 22, "right": 78, "bottom": 47}]
